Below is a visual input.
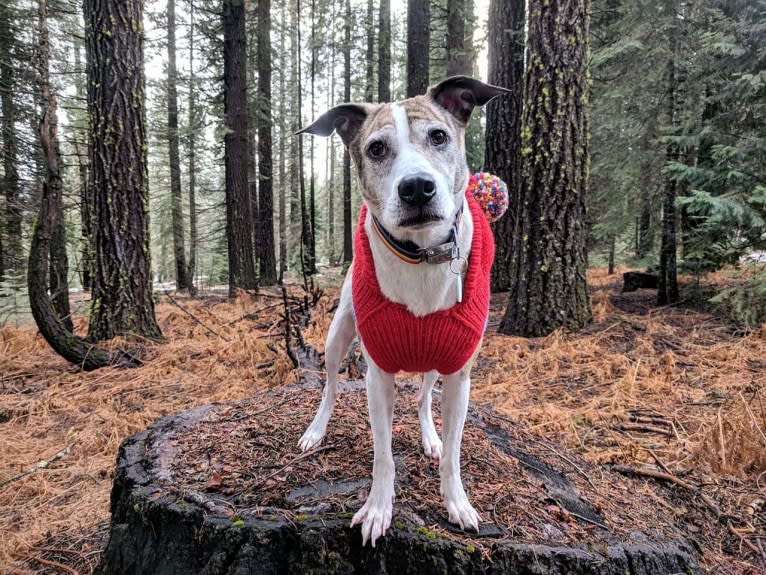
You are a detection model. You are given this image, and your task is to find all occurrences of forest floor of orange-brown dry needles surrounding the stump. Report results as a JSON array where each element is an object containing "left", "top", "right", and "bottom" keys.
[{"left": 0, "top": 270, "right": 766, "bottom": 575}]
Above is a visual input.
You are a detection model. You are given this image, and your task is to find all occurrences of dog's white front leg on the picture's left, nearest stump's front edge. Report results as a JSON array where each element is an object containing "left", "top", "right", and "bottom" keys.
[{"left": 351, "top": 352, "right": 394, "bottom": 547}]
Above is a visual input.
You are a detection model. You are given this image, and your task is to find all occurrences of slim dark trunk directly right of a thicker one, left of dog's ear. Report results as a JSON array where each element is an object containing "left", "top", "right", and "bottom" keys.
[{"left": 258, "top": 0, "right": 277, "bottom": 285}]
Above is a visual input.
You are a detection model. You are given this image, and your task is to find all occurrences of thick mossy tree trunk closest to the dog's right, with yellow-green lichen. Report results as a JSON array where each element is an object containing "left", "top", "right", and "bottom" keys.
[{"left": 500, "top": 0, "right": 591, "bottom": 337}]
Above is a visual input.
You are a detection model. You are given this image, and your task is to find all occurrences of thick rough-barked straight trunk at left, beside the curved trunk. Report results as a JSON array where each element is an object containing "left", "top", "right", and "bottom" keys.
[{"left": 83, "top": 0, "right": 162, "bottom": 340}]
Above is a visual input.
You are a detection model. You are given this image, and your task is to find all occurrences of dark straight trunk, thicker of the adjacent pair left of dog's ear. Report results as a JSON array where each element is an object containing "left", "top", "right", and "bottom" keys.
[{"left": 222, "top": 0, "right": 258, "bottom": 297}]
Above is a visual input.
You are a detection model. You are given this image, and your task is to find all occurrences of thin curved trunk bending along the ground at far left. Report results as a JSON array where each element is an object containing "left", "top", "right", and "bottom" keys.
[{"left": 27, "top": 0, "right": 137, "bottom": 370}]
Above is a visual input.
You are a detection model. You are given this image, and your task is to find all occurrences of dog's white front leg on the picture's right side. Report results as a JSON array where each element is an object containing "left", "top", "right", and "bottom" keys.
[{"left": 439, "top": 367, "right": 481, "bottom": 532}]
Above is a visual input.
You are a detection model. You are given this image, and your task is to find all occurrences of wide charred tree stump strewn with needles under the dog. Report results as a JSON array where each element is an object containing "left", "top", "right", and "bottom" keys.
[{"left": 99, "top": 382, "right": 699, "bottom": 575}]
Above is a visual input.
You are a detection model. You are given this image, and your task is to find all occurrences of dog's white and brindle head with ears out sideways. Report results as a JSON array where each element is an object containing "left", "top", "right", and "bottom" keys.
[{"left": 298, "top": 76, "right": 508, "bottom": 247}]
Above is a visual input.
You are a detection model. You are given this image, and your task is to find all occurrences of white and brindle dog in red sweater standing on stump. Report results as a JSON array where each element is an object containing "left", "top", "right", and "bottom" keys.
[{"left": 298, "top": 76, "right": 508, "bottom": 547}]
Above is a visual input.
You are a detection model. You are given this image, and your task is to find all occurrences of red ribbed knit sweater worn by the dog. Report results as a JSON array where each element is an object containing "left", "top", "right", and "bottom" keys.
[{"left": 352, "top": 192, "right": 495, "bottom": 375}]
